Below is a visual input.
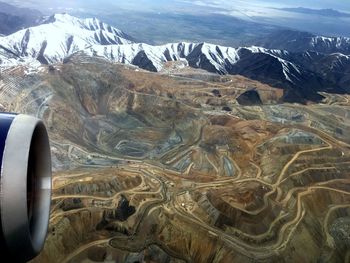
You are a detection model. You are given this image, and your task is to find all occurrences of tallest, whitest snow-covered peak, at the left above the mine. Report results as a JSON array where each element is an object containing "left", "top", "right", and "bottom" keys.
[{"left": 0, "top": 14, "right": 133, "bottom": 63}]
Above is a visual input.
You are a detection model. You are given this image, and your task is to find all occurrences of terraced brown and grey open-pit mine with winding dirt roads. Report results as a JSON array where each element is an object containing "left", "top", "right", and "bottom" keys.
[{"left": 0, "top": 54, "right": 350, "bottom": 263}]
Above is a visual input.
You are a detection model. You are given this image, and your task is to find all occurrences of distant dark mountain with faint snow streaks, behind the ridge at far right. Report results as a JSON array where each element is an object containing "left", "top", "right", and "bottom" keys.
[{"left": 253, "top": 30, "right": 350, "bottom": 55}]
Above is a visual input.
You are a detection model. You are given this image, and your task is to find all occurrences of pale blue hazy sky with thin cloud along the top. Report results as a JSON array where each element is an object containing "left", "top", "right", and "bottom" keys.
[{"left": 7, "top": 0, "right": 350, "bottom": 36}]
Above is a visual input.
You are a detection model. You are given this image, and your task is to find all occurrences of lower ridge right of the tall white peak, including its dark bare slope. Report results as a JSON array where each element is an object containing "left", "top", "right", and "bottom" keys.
[{"left": 84, "top": 43, "right": 345, "bottom": 102}]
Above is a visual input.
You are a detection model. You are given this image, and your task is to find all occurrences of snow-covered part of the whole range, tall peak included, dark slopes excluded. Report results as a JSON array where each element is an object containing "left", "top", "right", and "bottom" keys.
[{"left": 0, "top": 14, "right": 298, "bottom": 88}]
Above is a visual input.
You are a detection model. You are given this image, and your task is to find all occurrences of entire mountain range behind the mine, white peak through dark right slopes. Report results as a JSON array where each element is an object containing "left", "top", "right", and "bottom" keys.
[{"left": 0, "top": 14, "right": 350, "bottom": 102}]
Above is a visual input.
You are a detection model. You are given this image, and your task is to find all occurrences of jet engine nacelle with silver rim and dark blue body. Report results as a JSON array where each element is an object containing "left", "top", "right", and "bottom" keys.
[{"left": 0, "top": 113, "right": 51, "bottom": 262}]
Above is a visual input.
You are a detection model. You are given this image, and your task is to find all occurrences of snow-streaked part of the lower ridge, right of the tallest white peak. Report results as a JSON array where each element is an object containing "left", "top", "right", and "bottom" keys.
[{"left": 84, "top": 42, "right": 301, "bottom": 83}]
